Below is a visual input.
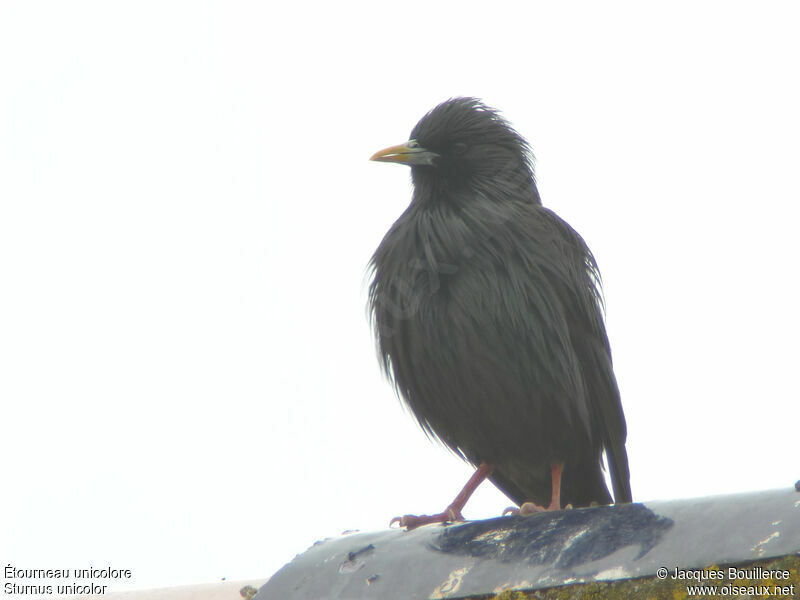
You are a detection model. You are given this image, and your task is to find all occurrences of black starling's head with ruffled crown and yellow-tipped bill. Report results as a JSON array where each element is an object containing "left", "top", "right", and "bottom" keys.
[{"left": 371, "top": 98, "right": 538, "bottom": 201}]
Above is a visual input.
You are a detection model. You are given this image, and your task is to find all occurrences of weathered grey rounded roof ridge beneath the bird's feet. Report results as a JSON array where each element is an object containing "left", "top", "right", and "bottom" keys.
[{"left": 255, "top": 488, "right": 800, "bottom": 600}]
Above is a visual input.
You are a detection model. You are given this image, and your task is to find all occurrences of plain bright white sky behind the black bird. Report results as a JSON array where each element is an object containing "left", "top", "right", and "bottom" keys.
[{"left": 0, "top": 0, "right": 800, "bottom": 589}]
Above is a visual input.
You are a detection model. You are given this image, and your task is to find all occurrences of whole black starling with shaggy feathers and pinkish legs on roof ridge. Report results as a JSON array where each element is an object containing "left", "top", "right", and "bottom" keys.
[{"left": 368, "top": 97, "right": 632, "bottom": 528}]
